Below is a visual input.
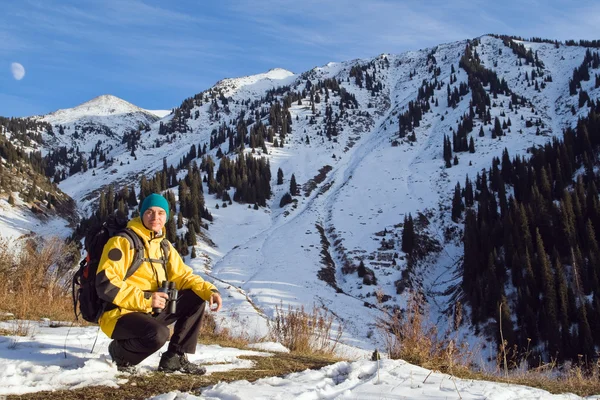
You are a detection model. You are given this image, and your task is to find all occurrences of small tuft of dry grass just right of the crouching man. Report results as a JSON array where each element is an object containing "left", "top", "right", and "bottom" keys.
[{"left": 269, "top": 306, "right": 342, "bottom": 356}]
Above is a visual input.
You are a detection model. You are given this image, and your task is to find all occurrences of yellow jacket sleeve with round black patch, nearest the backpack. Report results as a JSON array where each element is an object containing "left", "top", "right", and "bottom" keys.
[{"left": 96, "top": 236, "right": 152, "bottom": 313}]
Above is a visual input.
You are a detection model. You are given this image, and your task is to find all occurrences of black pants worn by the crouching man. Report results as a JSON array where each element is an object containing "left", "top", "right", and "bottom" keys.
[{"left": 112, "top": 289, "right": 205, "bottom": 365}]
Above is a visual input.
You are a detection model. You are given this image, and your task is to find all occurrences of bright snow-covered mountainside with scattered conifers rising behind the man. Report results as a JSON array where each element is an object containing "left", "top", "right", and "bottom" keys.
[{"left": 0, "top": 36, "right": 600, "bottom": 356}]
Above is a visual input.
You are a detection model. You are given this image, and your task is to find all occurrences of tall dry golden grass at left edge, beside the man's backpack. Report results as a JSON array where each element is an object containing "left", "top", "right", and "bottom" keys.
[{"left": 0, "top": 238, "right": 79, "bottom": 321}]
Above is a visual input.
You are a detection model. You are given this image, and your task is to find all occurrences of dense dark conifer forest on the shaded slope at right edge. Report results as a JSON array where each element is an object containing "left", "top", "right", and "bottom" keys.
[{"left": 452, "top": 101, "right": 600, "bottom": 361}]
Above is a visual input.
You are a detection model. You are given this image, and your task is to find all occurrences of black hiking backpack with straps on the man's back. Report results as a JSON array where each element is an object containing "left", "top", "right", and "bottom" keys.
[{"left": 71, "top": 215, "right": 169, "bottom": 323}]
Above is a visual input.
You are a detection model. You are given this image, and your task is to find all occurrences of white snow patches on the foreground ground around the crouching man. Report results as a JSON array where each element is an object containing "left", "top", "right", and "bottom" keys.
[{"left": 0, "top": 321, "right": 600, "bottom": 400}]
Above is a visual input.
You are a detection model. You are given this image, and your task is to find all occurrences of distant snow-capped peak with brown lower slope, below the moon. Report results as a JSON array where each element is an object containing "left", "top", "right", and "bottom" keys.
[{"left": 0, "top": 95, "right": 160, "bottom": 235}]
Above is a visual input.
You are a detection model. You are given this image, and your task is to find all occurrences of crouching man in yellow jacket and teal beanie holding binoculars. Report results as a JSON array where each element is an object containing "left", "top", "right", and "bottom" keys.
[{"left": 96, "top": 193, "right": 222, "bottom": 375}]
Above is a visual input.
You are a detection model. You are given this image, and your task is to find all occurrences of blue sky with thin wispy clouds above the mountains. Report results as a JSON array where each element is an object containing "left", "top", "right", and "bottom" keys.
[{"left": 0, "top": 0, "right": 600, "bottom": 116}]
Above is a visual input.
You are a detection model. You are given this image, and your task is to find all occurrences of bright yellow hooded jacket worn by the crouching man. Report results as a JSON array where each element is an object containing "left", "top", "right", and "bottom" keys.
[{"left": 96, "top": 217, "right": 217, "bottom": 337}]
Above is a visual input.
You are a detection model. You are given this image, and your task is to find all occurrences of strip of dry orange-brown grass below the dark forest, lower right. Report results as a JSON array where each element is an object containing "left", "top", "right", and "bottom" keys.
[{"left": 378, "top": 296, "right": 600, "bottom": 396}]
